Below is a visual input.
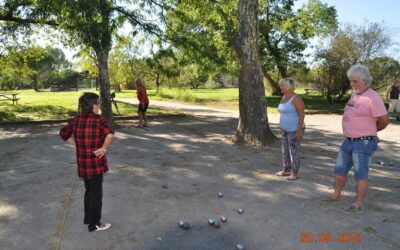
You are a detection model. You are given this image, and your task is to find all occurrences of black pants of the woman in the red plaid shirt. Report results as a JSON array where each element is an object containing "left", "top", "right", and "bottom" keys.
[{"left": 83, "top": 174, "right": 103, "bottom": 231}]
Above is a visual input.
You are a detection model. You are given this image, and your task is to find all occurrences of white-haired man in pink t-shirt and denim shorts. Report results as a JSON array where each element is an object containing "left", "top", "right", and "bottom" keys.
[{"left": 320, "top": 64, "right": 389, "bottom": 213}]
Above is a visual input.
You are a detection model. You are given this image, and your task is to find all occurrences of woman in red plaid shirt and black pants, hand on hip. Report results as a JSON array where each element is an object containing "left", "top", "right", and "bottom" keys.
[{"left": 60, "top": 93, "right": 114, "bottom": 232}]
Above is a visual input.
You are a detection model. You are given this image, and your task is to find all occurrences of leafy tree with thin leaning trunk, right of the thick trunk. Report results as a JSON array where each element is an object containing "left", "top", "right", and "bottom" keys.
[{"left": 259, "top": 0, "right": 337, "bottom": 95}]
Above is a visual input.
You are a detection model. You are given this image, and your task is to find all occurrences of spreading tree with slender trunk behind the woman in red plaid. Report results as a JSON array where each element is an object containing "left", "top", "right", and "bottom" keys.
[{"left": 0, "top": 0, "right": 164, "bottom": 121}]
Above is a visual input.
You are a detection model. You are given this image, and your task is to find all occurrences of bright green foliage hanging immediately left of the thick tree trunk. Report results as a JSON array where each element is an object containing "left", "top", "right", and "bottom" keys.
[{"left": 166, "top": 0, "right": 238, "bottom": 73}]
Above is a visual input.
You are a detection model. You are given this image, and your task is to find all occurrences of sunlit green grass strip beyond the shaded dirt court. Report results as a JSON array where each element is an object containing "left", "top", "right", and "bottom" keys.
[{"left": 0, "top": 88, "right": 344, "bottom": 121}]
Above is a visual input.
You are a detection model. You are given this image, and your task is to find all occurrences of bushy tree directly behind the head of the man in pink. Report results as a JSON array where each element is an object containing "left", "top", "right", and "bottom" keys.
[{"left": 312, "top": 23, "right": 399, "bottom": 103}]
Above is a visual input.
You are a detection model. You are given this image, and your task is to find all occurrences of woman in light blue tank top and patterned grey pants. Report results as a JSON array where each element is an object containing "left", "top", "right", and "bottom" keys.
[{"left": 276, "top": 78, "right": 305, "bottom": 180}]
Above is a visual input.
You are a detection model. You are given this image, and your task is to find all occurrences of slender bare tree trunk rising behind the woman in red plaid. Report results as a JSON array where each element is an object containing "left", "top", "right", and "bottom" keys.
[{"left": 96, "top": 49, "right": 113, "bottom": 123}]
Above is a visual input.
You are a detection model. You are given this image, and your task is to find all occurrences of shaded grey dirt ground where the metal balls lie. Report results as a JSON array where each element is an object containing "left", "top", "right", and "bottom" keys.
[{"left": 0, "top": 100, "right": 400, "bottom": 250}]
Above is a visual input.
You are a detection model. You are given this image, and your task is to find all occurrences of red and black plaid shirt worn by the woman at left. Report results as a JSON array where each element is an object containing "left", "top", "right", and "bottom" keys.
[{"left": 60, "top": 112, "right": 114, "bottom": 180}]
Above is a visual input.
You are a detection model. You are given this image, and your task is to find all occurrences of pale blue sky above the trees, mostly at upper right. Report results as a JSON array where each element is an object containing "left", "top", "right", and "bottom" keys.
[{"left": 58, "top": 0, "right": 400, "bottom": 60}]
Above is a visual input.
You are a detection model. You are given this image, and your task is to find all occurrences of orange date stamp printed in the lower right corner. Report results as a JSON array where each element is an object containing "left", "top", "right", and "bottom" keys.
[{"left": 299, "top": 231, "right": 362, "bottom": 244}]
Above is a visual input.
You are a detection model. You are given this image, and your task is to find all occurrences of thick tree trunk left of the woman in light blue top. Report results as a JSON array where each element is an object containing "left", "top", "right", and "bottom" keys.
[{"left": 235, "top": 0, "right": 276, "bottom": 146}]
